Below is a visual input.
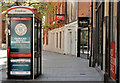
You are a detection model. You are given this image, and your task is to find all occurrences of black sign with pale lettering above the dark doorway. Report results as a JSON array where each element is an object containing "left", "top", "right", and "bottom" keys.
[{"left": 78, "top": 17, "right": 89, "bottom": 28}]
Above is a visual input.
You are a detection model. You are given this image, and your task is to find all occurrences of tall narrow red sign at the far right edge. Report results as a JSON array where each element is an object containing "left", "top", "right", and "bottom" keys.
[{"left": 110, "top": 42, "right": 116, "bottom": 80}]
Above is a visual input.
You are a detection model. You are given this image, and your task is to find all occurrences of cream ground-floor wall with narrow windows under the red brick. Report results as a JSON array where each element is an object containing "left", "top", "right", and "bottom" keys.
[{"left": 43, "top": 27, "right": 64, "bottom": 53}]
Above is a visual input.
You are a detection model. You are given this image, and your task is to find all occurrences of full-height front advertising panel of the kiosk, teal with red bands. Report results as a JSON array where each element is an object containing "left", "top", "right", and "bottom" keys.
[{"left": 10, "top": 17, "right": 31, "bottom": 76}]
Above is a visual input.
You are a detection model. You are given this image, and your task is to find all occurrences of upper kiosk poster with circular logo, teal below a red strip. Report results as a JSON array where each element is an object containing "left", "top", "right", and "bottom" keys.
[{"left": 11, "top": 18, "right": 31, "bottom": 49}]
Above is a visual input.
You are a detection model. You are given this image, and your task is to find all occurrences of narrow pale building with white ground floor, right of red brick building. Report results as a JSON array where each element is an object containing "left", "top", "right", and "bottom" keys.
[{"left": 64, "top": 0, "right": 78, "bottom": 56}]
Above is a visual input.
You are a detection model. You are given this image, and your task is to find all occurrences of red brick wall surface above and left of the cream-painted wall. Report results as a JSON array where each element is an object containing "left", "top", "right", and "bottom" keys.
[{"left": 43, "top": 2, "right": 65, "bottom": 45}]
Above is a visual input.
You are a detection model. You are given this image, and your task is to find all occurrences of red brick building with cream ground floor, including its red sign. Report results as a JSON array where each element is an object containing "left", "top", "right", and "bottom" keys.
[{"left": 43, "top": 2, "right": 66, "bottom": 53}]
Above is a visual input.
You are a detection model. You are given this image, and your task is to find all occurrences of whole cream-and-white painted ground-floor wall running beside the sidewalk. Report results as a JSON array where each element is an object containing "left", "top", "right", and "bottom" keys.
[{"left": 43, "top": 21, "right": 78, "bottom": 56}]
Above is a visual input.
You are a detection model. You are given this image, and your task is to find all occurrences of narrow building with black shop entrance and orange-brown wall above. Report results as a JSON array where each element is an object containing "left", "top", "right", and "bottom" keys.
[{"left": 77, "top": 2, "right": 91, "bottom": 58}]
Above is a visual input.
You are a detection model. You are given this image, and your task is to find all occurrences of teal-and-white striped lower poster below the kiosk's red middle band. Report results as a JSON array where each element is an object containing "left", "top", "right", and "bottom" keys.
[{"left": 10, "top": 58, "right": 31, "bottom": 76}]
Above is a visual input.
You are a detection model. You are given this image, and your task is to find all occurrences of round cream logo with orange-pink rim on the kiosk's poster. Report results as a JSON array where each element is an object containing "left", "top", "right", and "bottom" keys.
[{"left": 15, "top": 23, "right": 27, "bottom": 36}]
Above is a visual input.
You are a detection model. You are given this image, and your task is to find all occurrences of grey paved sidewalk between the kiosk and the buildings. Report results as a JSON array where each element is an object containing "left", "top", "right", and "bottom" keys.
[{"left": 3, "top": 51, "right": 103, "bottom": 83}]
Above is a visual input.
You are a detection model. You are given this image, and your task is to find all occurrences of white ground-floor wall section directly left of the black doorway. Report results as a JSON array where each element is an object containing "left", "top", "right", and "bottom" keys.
[{"left": 64, "top": 21, "right": 78, "bottom": 56}]
